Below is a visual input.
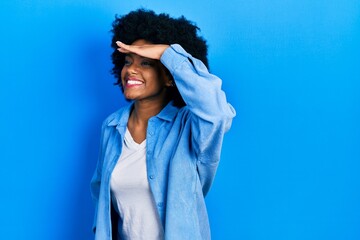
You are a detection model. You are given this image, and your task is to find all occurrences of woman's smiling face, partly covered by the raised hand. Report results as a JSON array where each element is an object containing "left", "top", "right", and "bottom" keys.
[{"left": 121, "top": 40, "right": 171, "bottom": 101}]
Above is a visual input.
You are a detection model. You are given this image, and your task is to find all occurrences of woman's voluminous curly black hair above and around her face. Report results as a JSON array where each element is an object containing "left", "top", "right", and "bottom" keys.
[{"left": 111, "top": 9, "right": 208, "bottom": 105}]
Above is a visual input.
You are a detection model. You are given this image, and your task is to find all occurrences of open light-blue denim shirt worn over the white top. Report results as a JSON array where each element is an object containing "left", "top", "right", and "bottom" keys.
[{"left": 91, "top": 44, "right": 235, "bottom": 240}]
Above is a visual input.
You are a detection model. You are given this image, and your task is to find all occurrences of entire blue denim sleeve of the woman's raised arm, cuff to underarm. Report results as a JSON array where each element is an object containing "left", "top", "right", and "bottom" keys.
[{"left": 160, "top": 44, "right": 236, "bottom": 194}]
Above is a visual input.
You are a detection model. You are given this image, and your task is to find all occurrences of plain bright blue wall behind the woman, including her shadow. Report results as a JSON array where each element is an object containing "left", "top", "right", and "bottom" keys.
[{"left": 0, "top": 0, "right": 360, "bottom": 240}]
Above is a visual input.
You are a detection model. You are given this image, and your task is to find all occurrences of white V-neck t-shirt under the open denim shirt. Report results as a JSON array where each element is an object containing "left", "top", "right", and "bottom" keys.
[{"left": 110, "top": 129, "right": 164, "bottom": 240}]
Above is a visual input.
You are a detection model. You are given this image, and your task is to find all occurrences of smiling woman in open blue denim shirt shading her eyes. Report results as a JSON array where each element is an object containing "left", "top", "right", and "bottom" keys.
[{"left": 91, "top": 9, "right": 235, "bottom": 240}]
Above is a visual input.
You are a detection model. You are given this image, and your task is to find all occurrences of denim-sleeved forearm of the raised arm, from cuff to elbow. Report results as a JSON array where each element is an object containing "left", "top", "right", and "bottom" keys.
[{"left": 160, "top": 44, "right": 235, "bottom": 122}]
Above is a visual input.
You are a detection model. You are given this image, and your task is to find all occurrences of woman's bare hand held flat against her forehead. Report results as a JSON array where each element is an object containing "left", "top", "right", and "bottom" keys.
[{"left": 116, "top": 41, "right": 169, "bottom": 60}]
